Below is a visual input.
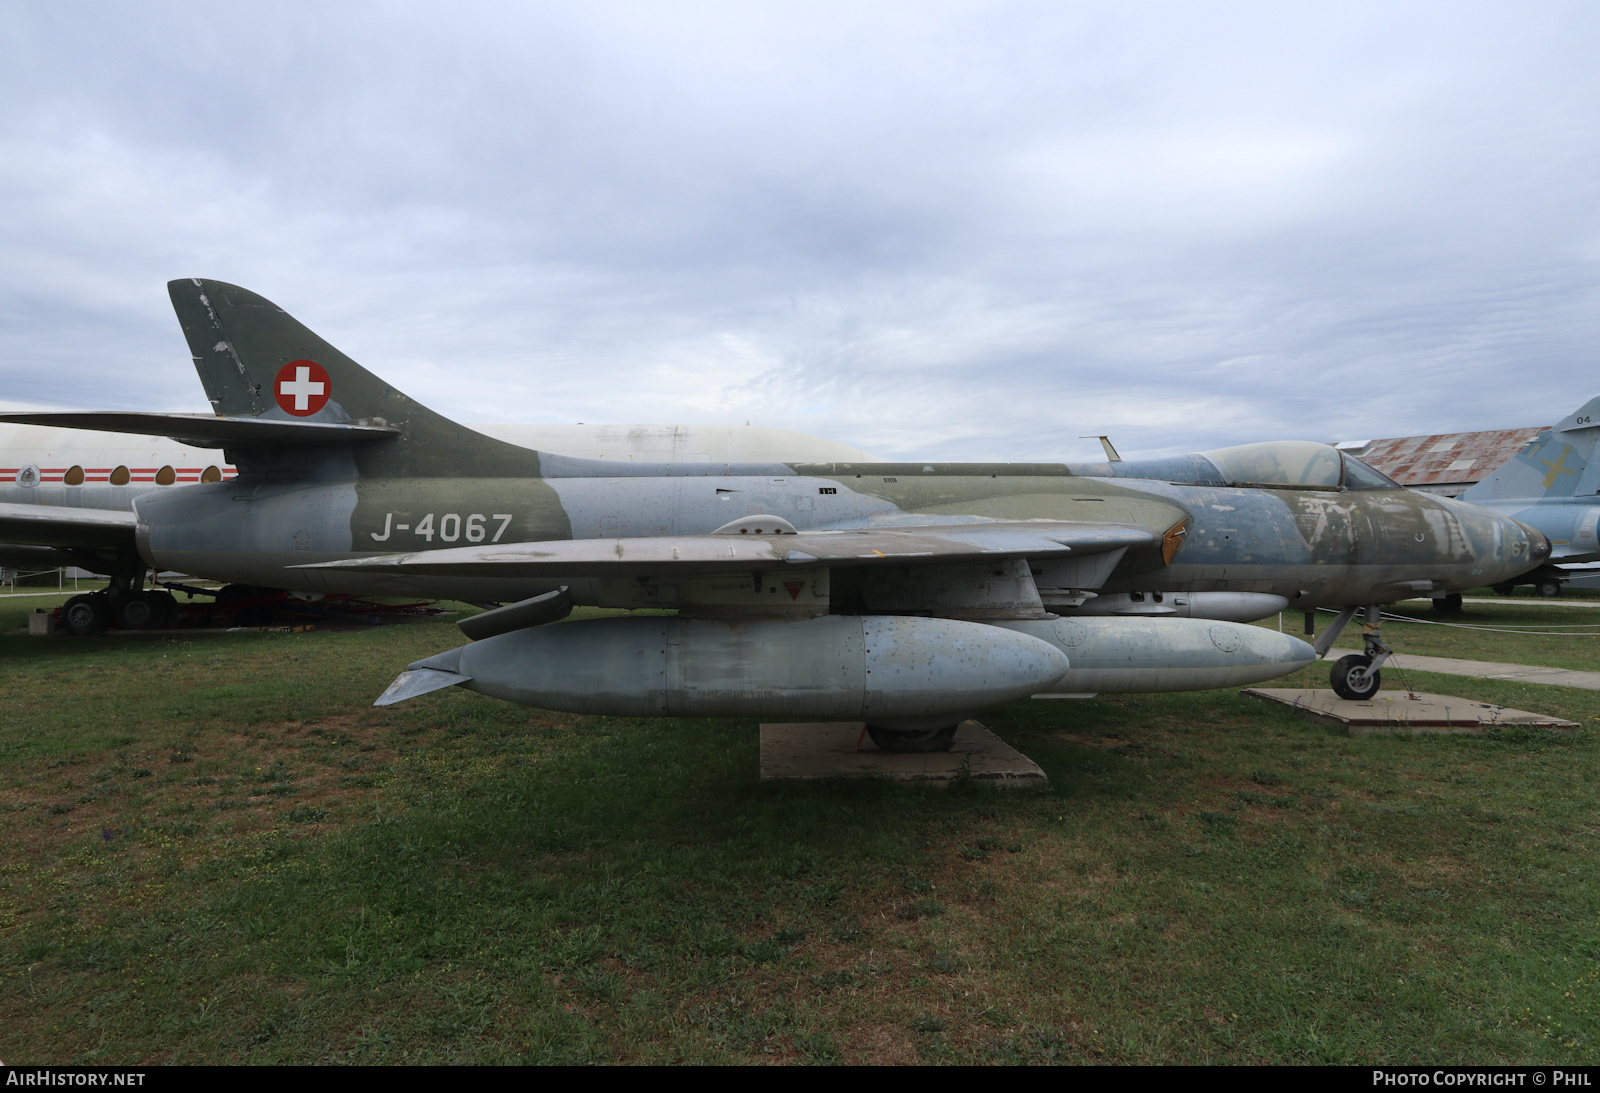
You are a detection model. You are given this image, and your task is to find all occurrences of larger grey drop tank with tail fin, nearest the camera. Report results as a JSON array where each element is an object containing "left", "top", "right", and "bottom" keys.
[{"left": 379, "top": 615, "right": 1069, "bottom": 730}]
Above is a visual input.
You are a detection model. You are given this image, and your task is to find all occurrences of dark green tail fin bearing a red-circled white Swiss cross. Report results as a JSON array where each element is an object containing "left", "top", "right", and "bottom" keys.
[{"left": 166, "top": 277, "right": 539, "bottom": 475}]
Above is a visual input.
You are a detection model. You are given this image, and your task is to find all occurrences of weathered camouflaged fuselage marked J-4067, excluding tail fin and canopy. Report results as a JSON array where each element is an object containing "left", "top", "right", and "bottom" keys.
[{"left": 124, "top": 453, "right": 1533, "bottom": 608}]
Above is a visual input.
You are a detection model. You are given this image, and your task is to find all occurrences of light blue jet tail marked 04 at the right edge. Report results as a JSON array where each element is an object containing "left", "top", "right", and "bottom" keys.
[{"left": 1461, "top": 398, "right": 1600, "bottom": 595}]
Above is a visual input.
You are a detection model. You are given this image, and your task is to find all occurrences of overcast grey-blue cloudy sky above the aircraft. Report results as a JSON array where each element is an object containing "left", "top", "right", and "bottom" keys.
[{"left": 0, "top": 0, "right": 1600, "bottom": 459}]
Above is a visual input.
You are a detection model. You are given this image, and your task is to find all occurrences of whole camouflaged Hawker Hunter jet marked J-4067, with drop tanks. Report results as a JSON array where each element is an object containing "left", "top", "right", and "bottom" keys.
[{"left": 0, "top": 278, "right": 1549, "bottom": 749}]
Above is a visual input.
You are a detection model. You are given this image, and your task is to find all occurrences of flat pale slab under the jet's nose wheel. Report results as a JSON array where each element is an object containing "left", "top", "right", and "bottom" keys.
[{"left": 1240, "top": 687, "right": 1578, "bottom": 736}]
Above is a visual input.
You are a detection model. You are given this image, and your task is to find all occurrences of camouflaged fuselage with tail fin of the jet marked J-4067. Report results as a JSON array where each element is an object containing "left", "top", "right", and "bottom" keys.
[{"left": 0, "top": 278, "right": 1549, "bottom": 610}]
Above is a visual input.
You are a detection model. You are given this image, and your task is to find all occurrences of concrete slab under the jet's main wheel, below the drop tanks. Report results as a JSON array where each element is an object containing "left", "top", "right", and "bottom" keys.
[{"left": 762, "top": 722, "right": 1046, "bottom": 787}]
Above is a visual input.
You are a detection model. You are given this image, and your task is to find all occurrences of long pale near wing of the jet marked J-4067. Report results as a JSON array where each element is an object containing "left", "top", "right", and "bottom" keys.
[{"left": 298, "top": 520, "right": 1158, "bottom": 578}]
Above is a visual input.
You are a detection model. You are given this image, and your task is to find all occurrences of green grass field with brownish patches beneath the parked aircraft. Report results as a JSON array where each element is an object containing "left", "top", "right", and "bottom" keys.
[{"left": 0, "top": 600, "right": 1600, "bottom": 1063}]
